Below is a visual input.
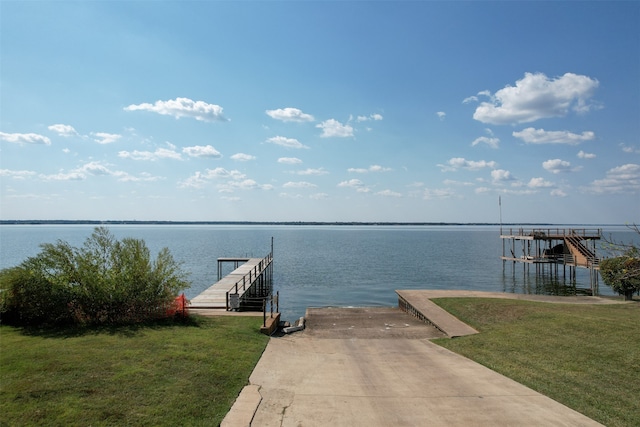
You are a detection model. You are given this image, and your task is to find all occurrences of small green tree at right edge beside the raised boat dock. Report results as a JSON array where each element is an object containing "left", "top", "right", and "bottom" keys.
[{"left": 600, "top": 224, "right": 640, "bottom": 300}]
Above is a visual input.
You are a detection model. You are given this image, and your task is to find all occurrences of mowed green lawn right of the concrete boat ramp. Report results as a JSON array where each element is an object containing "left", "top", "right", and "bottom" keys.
[{"left": 433, "top": 298, "right": 640, "bottom": 427}]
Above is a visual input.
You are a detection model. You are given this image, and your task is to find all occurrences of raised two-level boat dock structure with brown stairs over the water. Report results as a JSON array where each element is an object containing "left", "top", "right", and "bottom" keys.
[{"left": 500, "top": 228, "right": 602, "bottom": 290}]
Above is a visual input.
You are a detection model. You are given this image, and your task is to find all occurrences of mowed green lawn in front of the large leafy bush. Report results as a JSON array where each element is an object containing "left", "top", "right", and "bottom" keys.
[{"left": 0, "top": 317, "right": 268, "bottom": 426}]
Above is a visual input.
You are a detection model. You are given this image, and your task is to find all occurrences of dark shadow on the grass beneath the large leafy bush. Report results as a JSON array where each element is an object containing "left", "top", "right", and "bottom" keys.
[{"left": 8, "top": 315, "right": 203, "bottom": 338}]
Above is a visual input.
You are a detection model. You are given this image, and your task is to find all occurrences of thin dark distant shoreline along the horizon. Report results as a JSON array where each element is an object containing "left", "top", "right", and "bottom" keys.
[{"left": 0, "top": 219, "right": 624, "bottom": 227}]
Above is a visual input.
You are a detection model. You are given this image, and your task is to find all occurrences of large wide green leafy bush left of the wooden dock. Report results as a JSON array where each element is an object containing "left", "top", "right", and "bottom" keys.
[{"left": 0, "top": 227, "right": 189, "bottom": 325}]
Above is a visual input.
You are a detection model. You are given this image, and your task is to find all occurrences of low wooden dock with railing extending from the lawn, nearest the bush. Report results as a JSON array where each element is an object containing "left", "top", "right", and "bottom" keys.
[{"left": 190, "top": 252, "right": 273, "bottom": 310}]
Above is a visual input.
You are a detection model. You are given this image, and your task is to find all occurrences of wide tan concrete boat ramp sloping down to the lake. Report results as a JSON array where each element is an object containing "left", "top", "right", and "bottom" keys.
[{"left": 222, "top": 291, "right": 600, "bottom": 427}]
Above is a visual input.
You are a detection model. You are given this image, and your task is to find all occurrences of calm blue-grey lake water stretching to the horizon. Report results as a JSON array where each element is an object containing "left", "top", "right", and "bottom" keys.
[{"left": 0, "top": 225, "right": 637, "bottom": 320}]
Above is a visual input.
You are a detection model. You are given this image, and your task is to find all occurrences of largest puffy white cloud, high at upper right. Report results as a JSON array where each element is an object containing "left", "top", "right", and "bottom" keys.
[{"left": 465, "top": 73, "right": 599, "bottom": 125}]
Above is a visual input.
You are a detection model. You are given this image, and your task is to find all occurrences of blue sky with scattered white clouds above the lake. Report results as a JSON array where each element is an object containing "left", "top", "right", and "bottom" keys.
[{"left": 0, "top": 0, "right": 640, "bottom": 224}]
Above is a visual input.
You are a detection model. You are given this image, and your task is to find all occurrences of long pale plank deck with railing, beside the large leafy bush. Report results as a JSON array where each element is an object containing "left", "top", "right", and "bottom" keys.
[{"left": 190, "top": 253, "right": 273, "bottom": 310}]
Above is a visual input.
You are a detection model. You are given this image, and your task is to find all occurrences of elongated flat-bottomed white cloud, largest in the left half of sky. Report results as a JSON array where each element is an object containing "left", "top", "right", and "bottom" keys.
[{"left": 125, "top": 98, "right": 227, "bottom": 122}]
